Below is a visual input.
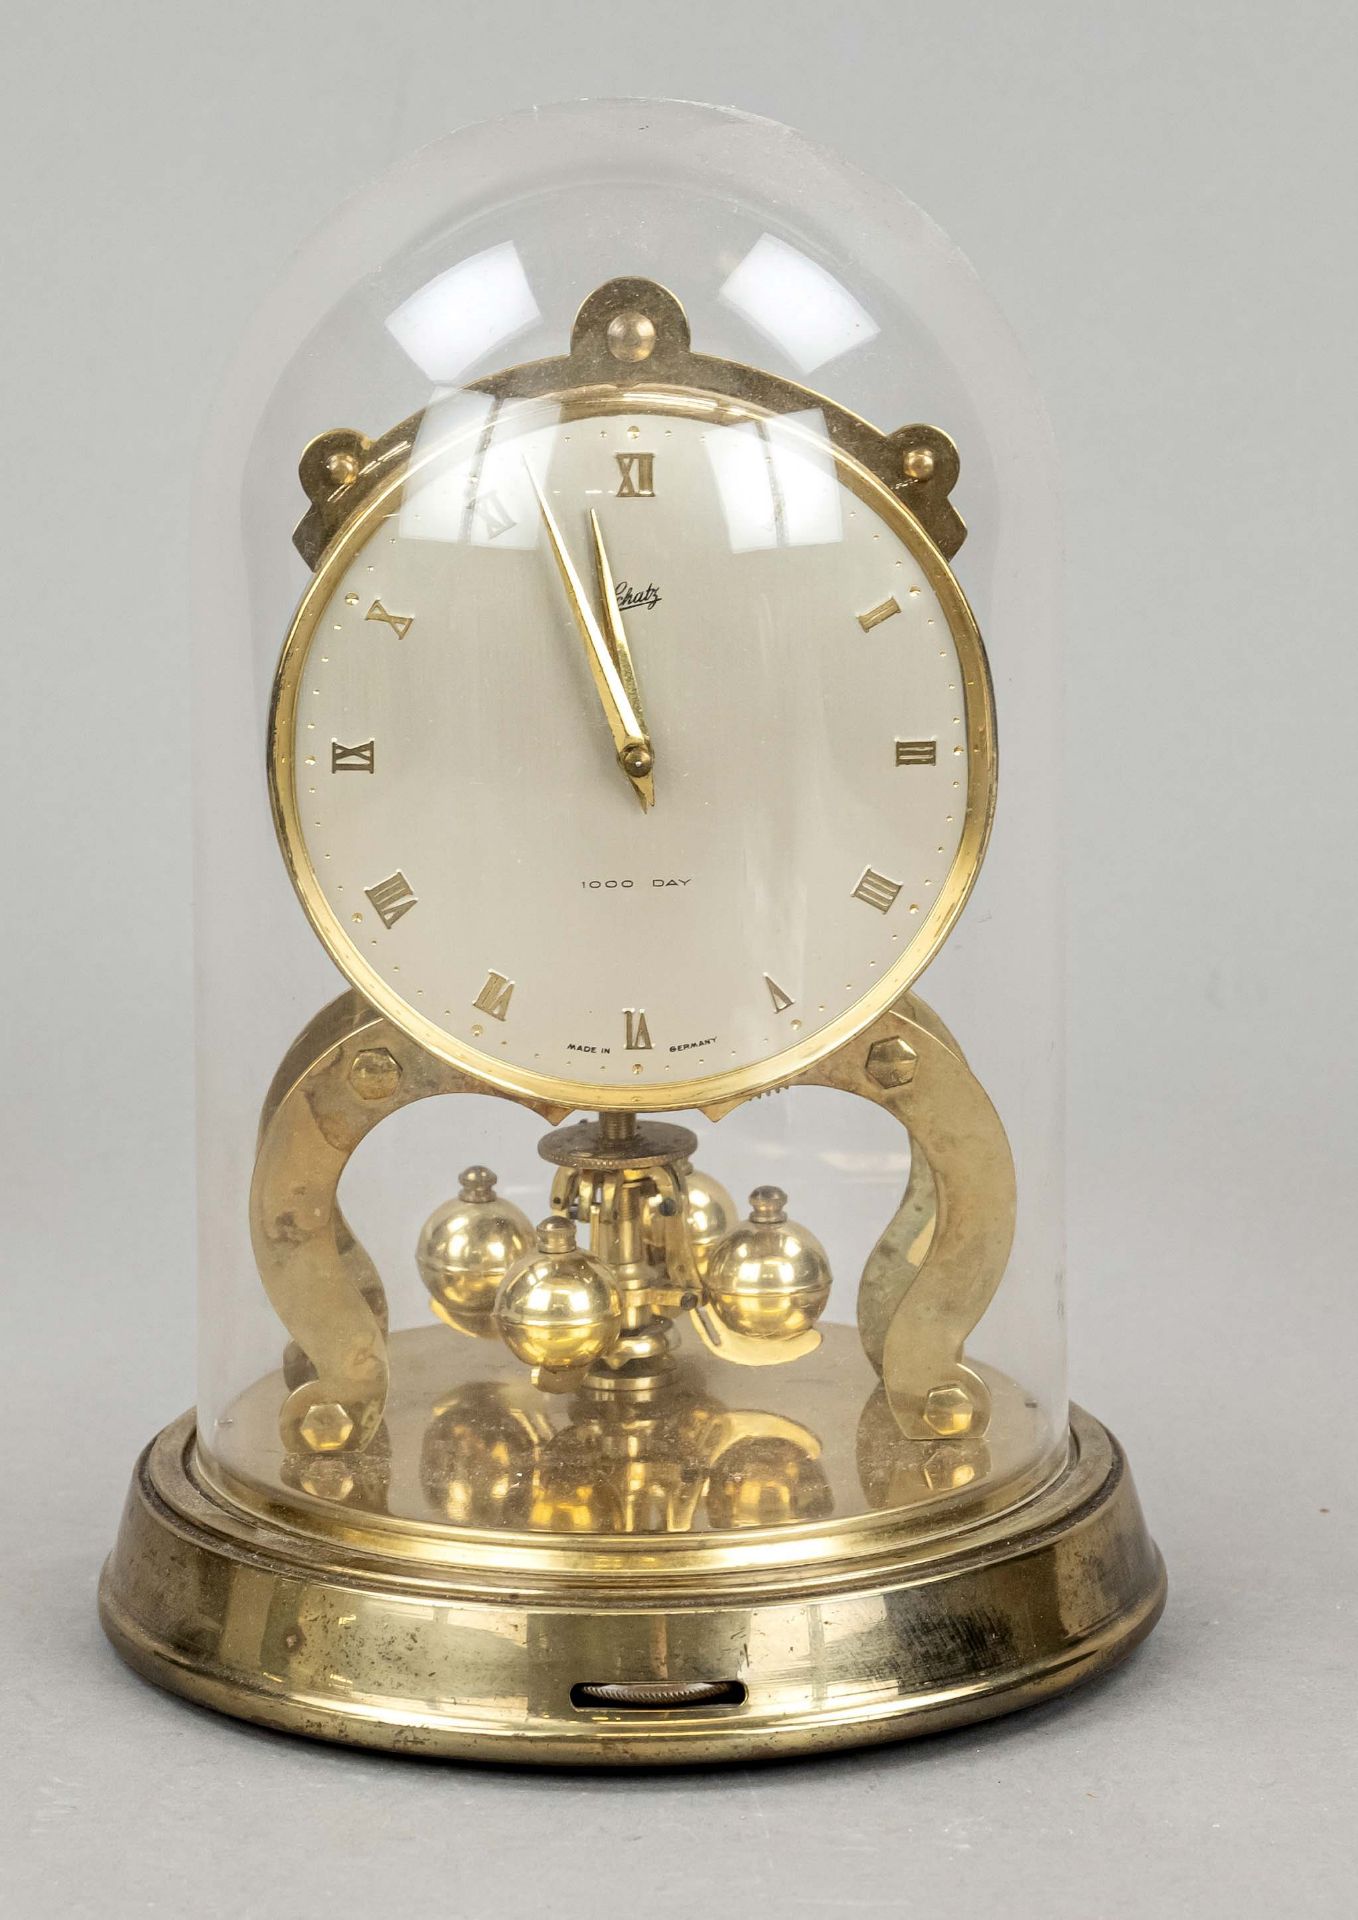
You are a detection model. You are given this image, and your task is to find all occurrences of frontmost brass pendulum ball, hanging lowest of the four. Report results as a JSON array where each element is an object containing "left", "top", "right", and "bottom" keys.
[{"left": 496, "top": 1213, "right": 622, "bottom": 1371}]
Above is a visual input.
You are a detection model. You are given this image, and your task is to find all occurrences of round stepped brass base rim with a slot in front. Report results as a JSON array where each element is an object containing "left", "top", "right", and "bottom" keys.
[{"left": 100, "top": 1409, "right": 1164, "bottom": 1764}]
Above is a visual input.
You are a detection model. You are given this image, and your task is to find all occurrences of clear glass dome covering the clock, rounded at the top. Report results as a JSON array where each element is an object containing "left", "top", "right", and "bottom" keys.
[{"left": 194, "top": 100, "right": 1066, "bottom": 1528}]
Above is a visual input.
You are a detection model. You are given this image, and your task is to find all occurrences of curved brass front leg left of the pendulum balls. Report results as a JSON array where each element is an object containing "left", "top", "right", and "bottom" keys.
[{"left": 250, "top": 993, "right": 565, "bottom": 1453}]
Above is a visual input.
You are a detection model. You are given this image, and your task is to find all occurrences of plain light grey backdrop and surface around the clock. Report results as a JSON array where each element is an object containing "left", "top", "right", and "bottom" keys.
[{"left": 0, "top": 0, "right": 1358, "bottom": 1920}]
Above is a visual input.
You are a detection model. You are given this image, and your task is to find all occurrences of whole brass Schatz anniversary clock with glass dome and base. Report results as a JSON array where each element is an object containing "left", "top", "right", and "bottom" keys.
[{"left": 102, "top": 102, "right": 1164, "bottom": 1761}]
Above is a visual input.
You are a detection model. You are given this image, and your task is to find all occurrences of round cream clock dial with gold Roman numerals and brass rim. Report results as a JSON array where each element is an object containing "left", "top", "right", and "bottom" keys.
[{"left": 271, "top": 392, "right": 995, "bottom": 1108}]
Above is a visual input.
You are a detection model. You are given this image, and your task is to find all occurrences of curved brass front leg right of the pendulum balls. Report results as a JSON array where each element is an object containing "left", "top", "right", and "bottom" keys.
[{"left": 797, "top": 995, "right": 1016, "bottom": 1440}]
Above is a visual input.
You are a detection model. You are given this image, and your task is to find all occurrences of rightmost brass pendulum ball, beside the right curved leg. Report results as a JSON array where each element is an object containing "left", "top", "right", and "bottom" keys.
[{"left": 707, "top": 1187, "right": 830, "bottom": 1340}]
